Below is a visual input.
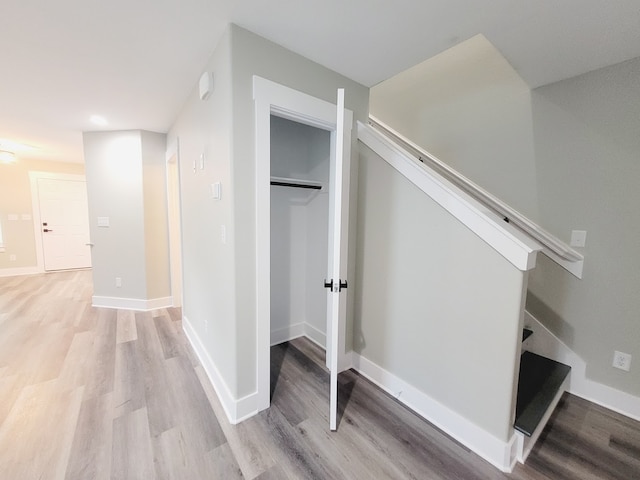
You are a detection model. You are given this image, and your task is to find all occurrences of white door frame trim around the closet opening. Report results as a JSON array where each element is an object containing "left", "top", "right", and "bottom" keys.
[{"left": 253, "top": 75, "right": 353, "bottom": 411}]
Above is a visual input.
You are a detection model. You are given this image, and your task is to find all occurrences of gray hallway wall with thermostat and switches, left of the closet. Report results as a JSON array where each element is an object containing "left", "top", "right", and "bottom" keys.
[{"left": 168, "top": 30, "right": 237, "bottom": 398}]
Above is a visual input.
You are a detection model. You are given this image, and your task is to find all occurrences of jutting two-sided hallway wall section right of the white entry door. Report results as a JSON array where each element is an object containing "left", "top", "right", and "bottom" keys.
[{"left": 83, "top": 130, "right": 171, "bottom": 300}]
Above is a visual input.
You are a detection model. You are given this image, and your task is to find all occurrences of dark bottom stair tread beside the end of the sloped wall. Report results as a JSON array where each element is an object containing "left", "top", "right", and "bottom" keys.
[{"left": 514, "top": 352, "right": 571, "bottom": 436}]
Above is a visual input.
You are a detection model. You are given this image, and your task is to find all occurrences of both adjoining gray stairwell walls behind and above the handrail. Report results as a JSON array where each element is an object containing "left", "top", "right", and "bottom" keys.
[{"left": 371, "top": 37, "right": 640, "bottom": 396}]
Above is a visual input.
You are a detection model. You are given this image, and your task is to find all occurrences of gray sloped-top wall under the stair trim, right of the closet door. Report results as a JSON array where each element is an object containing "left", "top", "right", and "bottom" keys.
[{"left": 353, "top": 145, "right": 526, "bottom": 442}]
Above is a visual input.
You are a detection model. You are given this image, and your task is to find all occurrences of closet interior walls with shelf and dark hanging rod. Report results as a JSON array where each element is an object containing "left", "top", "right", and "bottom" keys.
[{"left": 270, "top": 115, "right": 331, "bottom": 348}]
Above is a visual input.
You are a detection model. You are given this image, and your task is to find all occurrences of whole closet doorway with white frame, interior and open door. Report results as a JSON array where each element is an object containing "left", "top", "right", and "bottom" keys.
[{"left": 254, "top": 77, "right": 353, "bottom": 430}]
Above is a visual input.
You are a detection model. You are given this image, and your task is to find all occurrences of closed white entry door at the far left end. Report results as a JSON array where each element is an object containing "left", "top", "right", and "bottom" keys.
[{"left": 37, "top": 178, "right": 91, "bottom": 271}]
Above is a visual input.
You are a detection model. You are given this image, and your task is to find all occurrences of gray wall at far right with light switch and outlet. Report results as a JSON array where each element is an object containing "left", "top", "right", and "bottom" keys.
[{"left": 527, "top": 59, "right": 640, "bottom": 396}]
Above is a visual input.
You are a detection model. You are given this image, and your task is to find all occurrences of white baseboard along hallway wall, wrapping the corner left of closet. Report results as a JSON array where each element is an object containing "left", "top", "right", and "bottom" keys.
[{"left": 182, "top": 316, "right": 258, "bottom": 425}]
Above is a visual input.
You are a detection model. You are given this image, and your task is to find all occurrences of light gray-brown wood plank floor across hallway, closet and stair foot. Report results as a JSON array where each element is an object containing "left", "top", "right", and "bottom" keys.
[{"left": 0, "top": 271, "right": 640, "bottom": 480}]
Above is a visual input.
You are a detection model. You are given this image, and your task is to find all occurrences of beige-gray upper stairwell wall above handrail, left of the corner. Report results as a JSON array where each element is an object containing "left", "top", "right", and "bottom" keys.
[{"left": 371, "top": 35, "right": 538, "bottom": 220}]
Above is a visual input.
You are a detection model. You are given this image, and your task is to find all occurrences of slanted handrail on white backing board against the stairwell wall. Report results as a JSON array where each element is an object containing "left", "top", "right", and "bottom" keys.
[{"left": 369, "top": 116, "right": 584, "bottom": 278}]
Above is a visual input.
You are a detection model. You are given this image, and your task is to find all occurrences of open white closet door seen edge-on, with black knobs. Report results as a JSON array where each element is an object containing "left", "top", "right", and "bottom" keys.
[{"left": 325, "top": 88, "right": 351, "bottom": 430}]
